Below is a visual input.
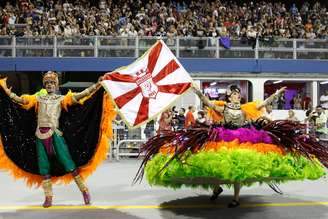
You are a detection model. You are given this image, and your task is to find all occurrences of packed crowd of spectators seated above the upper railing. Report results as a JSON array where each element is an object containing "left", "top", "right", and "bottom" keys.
[{"left": 0, "top": 0, "right": 328, "bottom": 39}]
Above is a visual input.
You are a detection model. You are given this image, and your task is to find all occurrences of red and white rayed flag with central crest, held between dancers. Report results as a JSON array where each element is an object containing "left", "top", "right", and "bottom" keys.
[{"left": 102, "top": 40, "right": 192, "bottom": 127}]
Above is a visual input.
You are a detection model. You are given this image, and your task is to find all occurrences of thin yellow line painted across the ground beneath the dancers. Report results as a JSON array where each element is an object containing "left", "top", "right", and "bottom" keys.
[{"left": 0, "top": 202, "right": 328, "bottom": 210}]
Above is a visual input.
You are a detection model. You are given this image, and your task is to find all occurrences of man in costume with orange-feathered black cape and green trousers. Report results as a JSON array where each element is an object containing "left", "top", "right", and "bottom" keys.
[{"left": 0, "top": 71, "right": 115, "bottom": 208}]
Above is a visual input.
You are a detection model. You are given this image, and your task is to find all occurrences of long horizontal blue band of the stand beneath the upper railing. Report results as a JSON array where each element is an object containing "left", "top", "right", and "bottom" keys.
[{"left": 0, "top": 57, "right": 328, "bottom": 74}]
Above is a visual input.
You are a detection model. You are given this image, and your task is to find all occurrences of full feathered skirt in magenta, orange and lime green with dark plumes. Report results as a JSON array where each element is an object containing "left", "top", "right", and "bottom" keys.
[{"left": 135, "top": 121, "right": 328, "bottom": 188}]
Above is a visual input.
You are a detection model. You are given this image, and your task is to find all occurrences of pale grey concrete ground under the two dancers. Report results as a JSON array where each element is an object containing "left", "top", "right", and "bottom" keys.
[{"left": 0, "top": 160, "right": 328, "bottom": 219}]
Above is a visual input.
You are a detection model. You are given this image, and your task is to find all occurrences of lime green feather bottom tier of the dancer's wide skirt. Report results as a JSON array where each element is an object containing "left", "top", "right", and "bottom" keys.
[{"left": 145, "top": 149, "right": 326, "bottom": 189}]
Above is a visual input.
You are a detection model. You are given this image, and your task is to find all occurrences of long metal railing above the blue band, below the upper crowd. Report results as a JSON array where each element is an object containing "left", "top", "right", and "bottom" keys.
[{"left": 0, "top": 36, "right": 328, "bottom": 59}]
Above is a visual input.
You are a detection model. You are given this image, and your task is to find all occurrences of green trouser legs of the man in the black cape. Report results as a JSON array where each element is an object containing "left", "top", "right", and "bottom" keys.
[{"left": 36, "top": 132, "right": 76, "bottom": 176}]
